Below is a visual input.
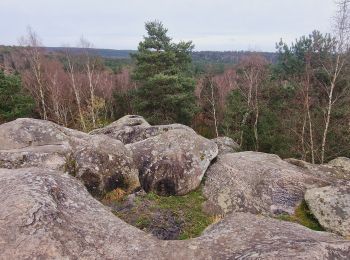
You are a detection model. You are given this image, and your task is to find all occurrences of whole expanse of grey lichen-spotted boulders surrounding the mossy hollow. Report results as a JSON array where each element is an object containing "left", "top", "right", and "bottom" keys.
[{"left": 0, "top": 116, "right": 350, "bottom": 259}]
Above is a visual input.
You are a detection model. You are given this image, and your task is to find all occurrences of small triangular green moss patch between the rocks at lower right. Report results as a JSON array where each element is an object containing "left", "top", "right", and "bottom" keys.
[{"left": 277, "top": 200, "right": 324, "bottom": 231}]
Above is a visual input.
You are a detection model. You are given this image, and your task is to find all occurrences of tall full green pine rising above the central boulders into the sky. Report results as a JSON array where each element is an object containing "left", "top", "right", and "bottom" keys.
[{"left": 132, "top": 21, "right": 196, "bottom": 124}]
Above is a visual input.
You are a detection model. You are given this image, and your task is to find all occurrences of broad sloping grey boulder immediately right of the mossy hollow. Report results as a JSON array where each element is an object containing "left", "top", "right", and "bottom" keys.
[{"left": 203, "top": 152, "right": 329, "bottom": 216}]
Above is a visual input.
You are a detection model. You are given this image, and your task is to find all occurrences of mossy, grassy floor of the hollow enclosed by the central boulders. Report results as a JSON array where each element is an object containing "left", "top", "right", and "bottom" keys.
[{"left": 112, "top": 188, "right": 215, "bottom": 240}]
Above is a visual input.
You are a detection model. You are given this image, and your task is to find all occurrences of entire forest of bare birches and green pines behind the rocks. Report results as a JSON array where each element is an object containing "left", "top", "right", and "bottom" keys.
[{"left": 0, "top": 2, "right": 350, "bottom": 163}]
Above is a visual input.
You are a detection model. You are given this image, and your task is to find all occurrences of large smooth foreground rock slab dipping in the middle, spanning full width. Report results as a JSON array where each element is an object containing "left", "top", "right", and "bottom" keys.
[{"left": 0, "top": 168, "right": 350, "bottom": 260}]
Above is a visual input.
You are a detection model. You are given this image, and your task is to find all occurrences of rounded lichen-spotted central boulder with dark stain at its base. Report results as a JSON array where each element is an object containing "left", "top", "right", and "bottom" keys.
[{"left": 126, "top": 129, "right": 218, "bottom": 195}]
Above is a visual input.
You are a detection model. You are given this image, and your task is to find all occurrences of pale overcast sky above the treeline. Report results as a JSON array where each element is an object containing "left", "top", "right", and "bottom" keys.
[{"left": 0, "top": 0, "right": 335, "bottom": 51}]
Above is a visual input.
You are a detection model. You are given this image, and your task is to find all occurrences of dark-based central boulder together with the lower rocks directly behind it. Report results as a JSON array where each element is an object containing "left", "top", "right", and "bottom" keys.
[{"left": 90, "top": 115, "right": 218, "bottom": 195}]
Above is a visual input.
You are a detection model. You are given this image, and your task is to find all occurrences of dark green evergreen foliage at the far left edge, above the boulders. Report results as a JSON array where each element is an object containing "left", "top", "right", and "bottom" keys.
[{"left": 0, "top": 70, "right": 35, "bottom": 123}]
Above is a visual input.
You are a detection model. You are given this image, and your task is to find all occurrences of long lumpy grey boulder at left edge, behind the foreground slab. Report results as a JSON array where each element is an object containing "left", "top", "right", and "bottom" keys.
[{"left": 0, "top": 118, "right": 140, "bottom": 196}]
